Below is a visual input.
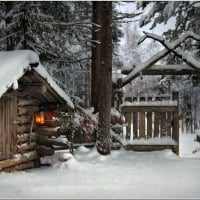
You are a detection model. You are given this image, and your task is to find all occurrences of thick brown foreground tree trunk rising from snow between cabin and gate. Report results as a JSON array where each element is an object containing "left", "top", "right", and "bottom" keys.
[{"left": 92, "top": 1, "right": 112, "bottom": 155}]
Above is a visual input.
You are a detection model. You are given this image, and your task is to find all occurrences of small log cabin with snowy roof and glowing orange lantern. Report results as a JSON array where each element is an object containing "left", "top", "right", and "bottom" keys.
[{"left": 0, "top": 50, "right": 74, "bottom": 172}]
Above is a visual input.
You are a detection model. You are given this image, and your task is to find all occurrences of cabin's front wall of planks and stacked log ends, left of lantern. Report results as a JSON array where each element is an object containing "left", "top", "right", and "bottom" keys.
[{"left": 0, "top": 95, "right": 39, "bottom": 171}]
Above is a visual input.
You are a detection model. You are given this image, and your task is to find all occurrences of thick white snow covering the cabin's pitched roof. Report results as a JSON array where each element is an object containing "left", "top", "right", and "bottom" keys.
[{"left": 0, "top": 50, "right": 74, "bottom": 108}]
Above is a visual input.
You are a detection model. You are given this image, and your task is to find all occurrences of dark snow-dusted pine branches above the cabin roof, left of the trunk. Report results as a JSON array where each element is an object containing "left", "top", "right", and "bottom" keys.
[{"left": 0, "top": 1, "right": 92, "bottom": 101}]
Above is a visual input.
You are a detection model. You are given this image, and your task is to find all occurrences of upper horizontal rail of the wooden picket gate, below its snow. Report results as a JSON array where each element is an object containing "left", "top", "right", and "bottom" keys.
[{"left": 121, "top": 105, "right": 177, "bottom": 113}]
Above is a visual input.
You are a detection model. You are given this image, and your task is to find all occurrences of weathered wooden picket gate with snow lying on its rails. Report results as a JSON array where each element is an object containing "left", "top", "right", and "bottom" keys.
[{"left": 120, "top": 92, "right": 179, "bottom": 154}]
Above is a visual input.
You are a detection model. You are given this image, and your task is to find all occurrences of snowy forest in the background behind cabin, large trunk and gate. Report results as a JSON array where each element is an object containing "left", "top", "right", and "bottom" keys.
[{"left": 0, "top": 1, "right": 200, "bottom": 132}]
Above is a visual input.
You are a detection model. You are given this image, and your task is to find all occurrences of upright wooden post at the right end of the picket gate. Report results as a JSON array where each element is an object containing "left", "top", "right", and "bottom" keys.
[{"left": 172, "top": 92, "right": 179, "bottom": 155}]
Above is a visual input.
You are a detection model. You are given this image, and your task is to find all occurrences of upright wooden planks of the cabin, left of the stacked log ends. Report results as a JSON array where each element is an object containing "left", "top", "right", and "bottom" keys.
[{"left": 0, "top": 96, "right": 16, "bottom": 160}]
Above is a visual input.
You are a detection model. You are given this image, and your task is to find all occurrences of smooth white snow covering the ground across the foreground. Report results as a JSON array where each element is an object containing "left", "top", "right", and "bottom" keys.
[{"left": 0, "top": 131, "right": 200, "bottom": 199}]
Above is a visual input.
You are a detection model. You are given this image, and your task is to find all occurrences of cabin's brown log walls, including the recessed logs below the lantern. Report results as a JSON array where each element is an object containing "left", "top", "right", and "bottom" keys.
[{"left": 0, "top": 92, "right": 69, "bottom": 172}]
